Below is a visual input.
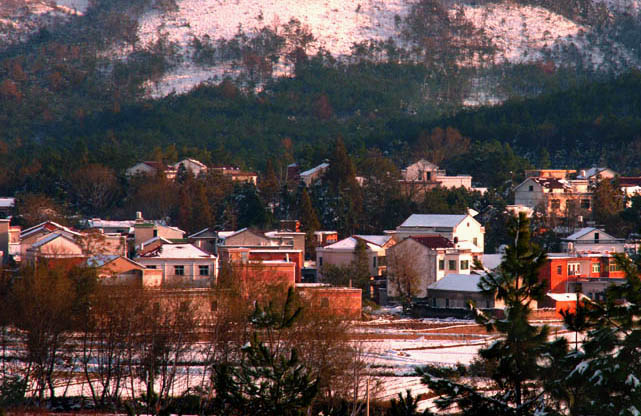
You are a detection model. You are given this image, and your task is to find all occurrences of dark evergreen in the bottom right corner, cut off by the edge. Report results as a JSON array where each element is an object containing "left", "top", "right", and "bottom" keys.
[{"left": 546, "top": 255, "right": 641, "bottom": 415}]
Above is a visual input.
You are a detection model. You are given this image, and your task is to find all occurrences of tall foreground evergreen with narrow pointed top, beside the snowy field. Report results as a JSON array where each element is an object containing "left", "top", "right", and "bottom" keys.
[{"left": 420, "top": 214, "right": 549, "bottom": 415}]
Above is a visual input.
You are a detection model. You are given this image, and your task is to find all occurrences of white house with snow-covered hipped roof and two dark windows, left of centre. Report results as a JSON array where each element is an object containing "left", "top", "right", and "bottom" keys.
[{"left": 135, "top": 244, "right": 218, "bottom": 287}]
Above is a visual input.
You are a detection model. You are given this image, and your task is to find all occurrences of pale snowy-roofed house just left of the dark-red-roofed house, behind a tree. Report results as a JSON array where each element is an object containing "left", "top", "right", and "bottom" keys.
[{"left": 316, "top": 235, "right": 395, "bottom": 280}]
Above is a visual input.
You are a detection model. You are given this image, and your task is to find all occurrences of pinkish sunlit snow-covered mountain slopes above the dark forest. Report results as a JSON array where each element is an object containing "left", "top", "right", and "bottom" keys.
[{"left": 0, "top": 0, "right": 641, "bottom": 101}]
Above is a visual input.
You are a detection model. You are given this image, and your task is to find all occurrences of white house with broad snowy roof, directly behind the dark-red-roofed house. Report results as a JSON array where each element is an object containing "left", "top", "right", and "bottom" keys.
[{"left": 390, "top": 214, "right": 485, "bottom": 256}]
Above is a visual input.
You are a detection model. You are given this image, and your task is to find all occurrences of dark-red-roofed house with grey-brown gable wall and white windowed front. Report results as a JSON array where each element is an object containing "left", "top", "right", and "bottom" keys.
[{"left": 387, "top": 234, "right": 474, "bottom": 298}]
